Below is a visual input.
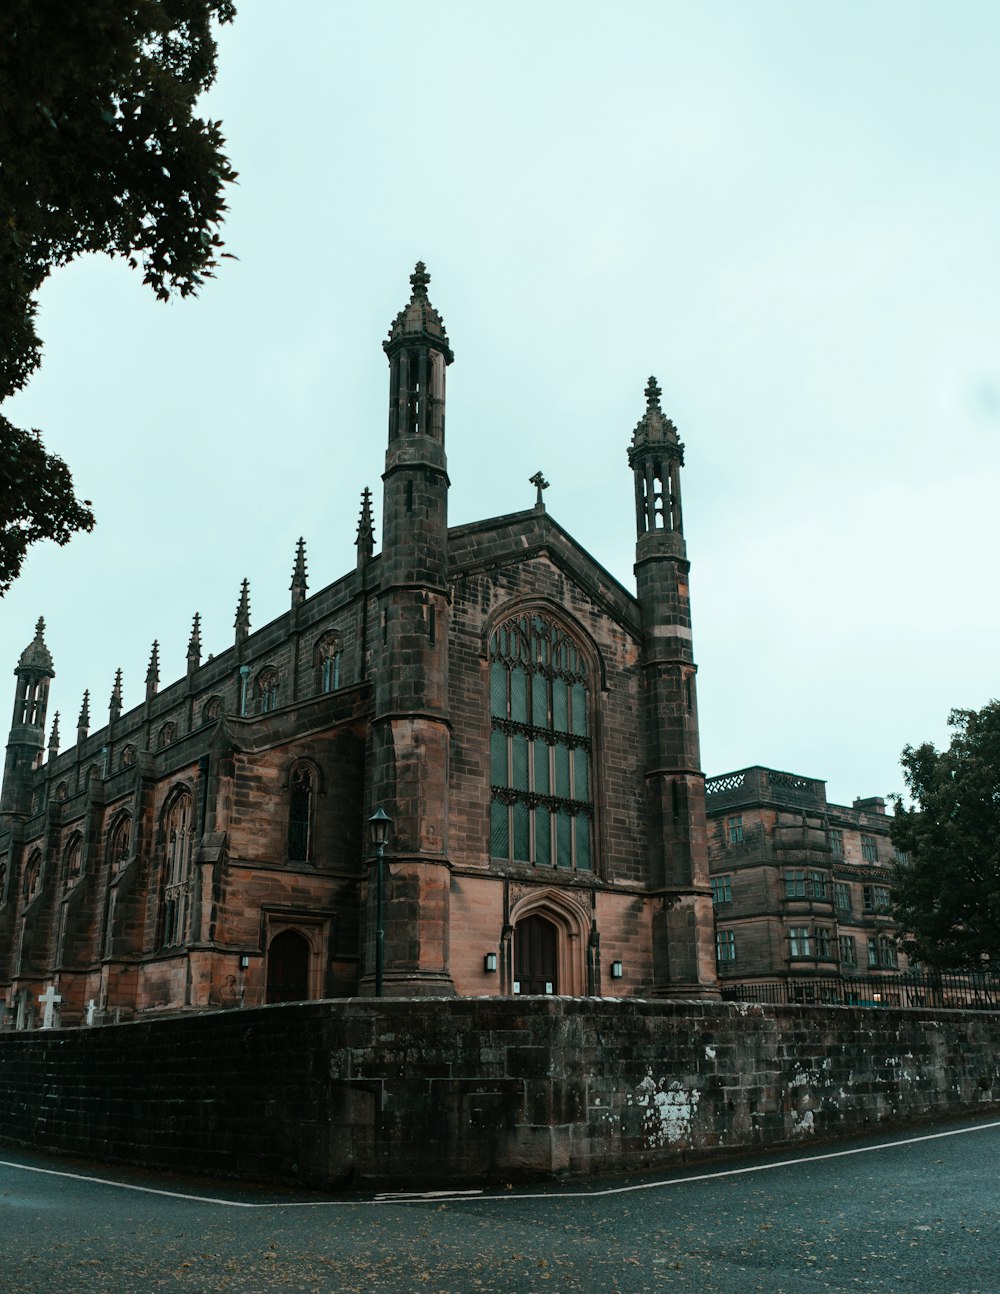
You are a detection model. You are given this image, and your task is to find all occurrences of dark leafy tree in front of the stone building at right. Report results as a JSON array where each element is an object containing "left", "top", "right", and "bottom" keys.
[{"left": 893, "top": 701, "right": 1000, "bottom": 969}]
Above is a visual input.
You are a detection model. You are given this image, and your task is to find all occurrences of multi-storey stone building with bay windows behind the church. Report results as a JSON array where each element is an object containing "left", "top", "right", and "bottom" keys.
[{"left": 705, "top": 767, "right": 906, "bottom": 1000}]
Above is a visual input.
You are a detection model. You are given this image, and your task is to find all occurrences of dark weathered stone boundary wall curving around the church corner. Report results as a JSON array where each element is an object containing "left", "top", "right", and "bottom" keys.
[{"left": 0, "top": 998, "right": 1000, "bottom": 1187}]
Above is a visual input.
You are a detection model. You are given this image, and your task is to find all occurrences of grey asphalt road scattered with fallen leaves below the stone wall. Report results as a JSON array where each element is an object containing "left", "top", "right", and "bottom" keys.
[{"left": 0, "top": 1121, "right": 1000, "bottom": 1294}]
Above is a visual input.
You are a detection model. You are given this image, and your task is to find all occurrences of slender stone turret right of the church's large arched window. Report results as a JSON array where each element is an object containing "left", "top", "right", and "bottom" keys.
[{"left": 629, "top": 378, "right": 718, "bottom": 998}]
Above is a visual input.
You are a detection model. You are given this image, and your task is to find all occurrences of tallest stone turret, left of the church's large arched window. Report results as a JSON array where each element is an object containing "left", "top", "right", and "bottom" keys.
[{"left": 364, "top": 263, "right": 454, "bottom": 995}]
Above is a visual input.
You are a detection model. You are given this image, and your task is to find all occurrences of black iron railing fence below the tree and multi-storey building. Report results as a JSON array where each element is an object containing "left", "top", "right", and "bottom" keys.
[{"left": 721, "top": 972, "right": 1000, "bottom": 1011}]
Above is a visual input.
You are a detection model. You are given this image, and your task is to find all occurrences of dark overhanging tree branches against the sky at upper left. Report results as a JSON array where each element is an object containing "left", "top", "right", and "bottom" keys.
[{"left": 0, "top": 0, "right": 235, "bottom": 594}]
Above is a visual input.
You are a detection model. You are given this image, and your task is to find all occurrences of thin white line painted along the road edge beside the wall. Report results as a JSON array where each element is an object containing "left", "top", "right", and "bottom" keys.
[{"left": 0, "top": 1119, "right": 1000, "bottom": 1209}]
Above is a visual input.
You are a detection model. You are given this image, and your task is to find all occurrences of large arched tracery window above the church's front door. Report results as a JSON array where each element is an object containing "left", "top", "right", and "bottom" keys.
[{"left": 489, "top": 612, "right": 594, "bottom": 871}]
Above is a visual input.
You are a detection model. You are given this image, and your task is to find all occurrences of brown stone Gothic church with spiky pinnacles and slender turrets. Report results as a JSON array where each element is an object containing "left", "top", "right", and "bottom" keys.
[{"left": 0, "top": 264, "right": 717, "bottom": 1027}]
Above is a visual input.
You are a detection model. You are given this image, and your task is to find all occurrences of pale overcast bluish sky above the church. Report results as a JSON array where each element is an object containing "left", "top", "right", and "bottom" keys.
[{"left": 0, "top": 0, "right": 1000, "bottom": 804}]
